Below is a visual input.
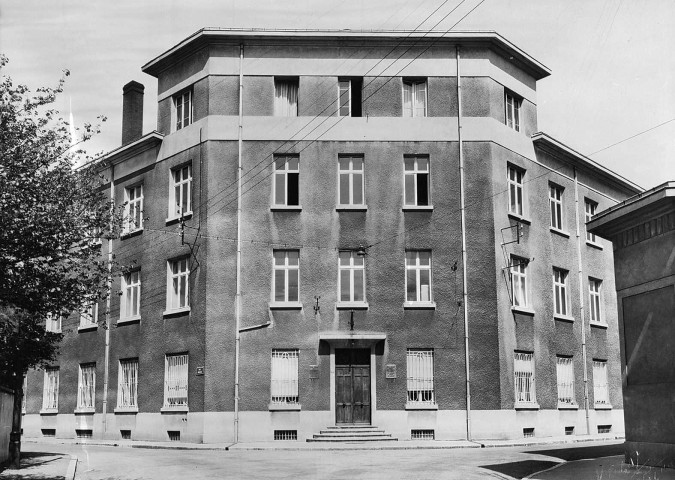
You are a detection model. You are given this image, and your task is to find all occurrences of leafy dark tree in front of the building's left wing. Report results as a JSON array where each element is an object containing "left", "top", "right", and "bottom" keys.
[{"left": 0, "top": 55, "right": 116, "bottom": 468}]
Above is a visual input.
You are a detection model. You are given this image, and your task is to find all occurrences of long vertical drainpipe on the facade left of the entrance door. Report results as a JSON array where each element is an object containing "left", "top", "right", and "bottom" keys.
[{"left": 234, "top": 44, "right": 244, "bottom": 443}]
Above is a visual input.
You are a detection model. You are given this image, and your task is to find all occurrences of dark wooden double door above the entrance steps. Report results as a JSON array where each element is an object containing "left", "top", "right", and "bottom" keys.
[{"left": 335, "top": 348, "right": 370, "bottom": 424}]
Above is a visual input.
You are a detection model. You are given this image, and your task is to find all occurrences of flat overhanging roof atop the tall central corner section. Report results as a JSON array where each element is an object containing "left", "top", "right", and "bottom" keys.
[{"left": 141, "top": 27, "right": 551, "bottom": 80}]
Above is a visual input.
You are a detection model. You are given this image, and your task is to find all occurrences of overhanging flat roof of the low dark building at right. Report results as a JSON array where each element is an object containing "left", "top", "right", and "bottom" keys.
[{"left": 587, "top": 181, "right": 675, "bottom": 238}]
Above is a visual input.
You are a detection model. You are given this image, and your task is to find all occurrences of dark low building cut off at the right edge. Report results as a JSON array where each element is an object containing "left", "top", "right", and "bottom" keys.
[{"left": 588, "top": 182, "right": 675, "bottom": 468}]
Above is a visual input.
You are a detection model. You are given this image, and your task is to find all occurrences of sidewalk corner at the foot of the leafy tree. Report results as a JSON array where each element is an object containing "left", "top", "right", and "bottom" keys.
[{"left": 0, "top": 452, "right": 77, "bottom": 480}]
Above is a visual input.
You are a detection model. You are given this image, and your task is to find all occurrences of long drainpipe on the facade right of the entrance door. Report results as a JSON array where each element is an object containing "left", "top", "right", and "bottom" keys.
[{"left": 455, "top": 45, "right": 471, "bottom": 441}]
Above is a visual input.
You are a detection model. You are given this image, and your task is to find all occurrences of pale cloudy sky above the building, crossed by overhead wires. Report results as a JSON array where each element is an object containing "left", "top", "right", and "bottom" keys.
[{"left": 0, "top": 0, "right": 675, "bottom": 188}]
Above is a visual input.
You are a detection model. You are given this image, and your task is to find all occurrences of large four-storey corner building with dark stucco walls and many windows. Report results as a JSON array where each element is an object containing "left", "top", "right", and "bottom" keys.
[{"left": 25, "top": 29, "right": 640, "bottom": 442}]
